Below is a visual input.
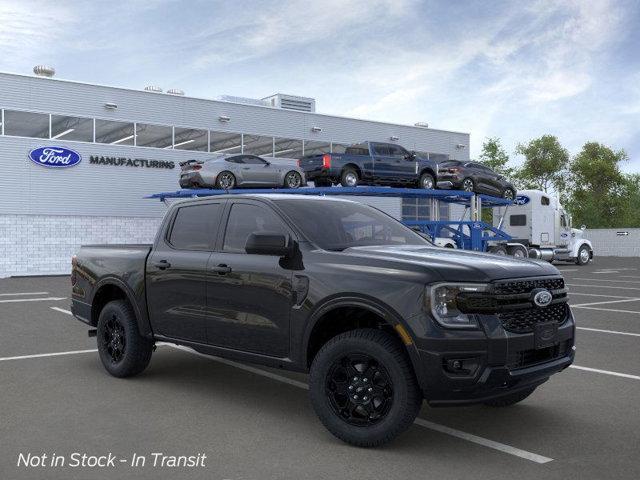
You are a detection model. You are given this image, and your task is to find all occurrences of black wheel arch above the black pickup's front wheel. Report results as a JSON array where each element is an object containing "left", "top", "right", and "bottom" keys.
[{"left": 303, "top": 296, "right": 422, "bottom": 384}]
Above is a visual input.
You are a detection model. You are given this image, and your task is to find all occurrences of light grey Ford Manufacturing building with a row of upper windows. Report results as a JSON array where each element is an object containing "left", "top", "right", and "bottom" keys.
[{"left": 0, "top": 67, "right": 469, "bottom": 277}]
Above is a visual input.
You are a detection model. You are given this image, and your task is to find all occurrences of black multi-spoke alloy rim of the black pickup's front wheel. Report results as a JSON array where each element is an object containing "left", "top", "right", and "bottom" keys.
[{"left": 325, "top": 353, "right": 393, "bottom": 426}]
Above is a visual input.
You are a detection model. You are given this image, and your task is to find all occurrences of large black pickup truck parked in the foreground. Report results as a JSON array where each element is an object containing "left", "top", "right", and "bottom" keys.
[{"left": 71, "top": 194, "right": 575, "bottom": 446}]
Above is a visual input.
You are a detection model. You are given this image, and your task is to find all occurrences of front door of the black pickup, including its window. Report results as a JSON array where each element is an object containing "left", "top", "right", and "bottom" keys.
[{"left": 207, "top": 200, "right": 294, "bottom": 358}]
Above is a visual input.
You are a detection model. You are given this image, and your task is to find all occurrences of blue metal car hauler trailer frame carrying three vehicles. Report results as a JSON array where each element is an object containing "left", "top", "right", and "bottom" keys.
[{"left": 145, "top": 187, "right": 513, "bottom": 251}]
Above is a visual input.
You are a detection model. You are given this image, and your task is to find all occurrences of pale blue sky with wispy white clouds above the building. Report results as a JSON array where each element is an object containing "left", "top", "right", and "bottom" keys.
[{"left": 0, "top": 0, "right": 640, "bottom": 172}]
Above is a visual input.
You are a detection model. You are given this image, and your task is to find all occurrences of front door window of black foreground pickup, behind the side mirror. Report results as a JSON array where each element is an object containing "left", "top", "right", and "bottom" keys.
[{"left": 222, "top": 203, "right": 288, "bottom": 253}]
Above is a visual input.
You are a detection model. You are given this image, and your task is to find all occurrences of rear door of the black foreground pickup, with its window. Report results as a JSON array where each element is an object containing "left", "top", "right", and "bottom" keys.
[{"left": 146, "top": 201, "right": 224, "bottom": 343}]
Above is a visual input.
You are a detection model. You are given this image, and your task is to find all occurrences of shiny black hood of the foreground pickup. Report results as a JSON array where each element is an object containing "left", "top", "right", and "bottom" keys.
[{"left": 342, "top": 245, "right": 560, "bottom": 282}]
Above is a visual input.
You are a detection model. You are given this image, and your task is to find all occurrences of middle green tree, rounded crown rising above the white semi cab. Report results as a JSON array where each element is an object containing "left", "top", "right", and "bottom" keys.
[{"left": 516, "top": 135, "right": 569, "bottom": 193}]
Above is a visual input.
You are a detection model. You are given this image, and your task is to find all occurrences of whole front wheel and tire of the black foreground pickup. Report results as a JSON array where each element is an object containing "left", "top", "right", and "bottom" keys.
[{"left": 309, "top": 328, "right": 422, "bottom": 447}]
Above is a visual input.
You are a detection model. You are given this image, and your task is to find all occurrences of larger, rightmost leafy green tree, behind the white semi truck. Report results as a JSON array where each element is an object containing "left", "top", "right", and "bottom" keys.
[{"left": 568, "top": 142, "right": 628, "bottom": 228}]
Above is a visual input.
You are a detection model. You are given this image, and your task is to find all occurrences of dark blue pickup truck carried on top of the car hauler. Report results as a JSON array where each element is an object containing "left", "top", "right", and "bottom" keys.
[{"left": 298, "top": 142, "right": 438, "bottom": 189}]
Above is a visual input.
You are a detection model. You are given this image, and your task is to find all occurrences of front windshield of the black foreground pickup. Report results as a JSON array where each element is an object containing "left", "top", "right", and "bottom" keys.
[{"left": 275, "top": 199, "right": 431, "bottom": 251}]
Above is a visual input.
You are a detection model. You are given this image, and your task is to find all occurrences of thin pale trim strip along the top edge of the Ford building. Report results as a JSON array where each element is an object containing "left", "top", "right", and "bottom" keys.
[{"left": 0, "top": 71, "right": 471, "bottom": 136}]
